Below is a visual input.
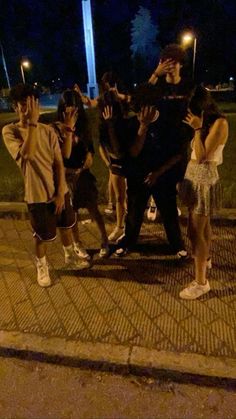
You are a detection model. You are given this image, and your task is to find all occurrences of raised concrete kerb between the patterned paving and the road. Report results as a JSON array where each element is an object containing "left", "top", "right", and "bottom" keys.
[{"left": 0, "top": 331, "right": 236, "bottom": 386}]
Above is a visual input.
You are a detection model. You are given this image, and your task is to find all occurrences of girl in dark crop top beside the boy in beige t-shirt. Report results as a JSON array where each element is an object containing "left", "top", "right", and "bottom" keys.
[{"left": 53, "top": 89, "right": 109, "bottom": 258}]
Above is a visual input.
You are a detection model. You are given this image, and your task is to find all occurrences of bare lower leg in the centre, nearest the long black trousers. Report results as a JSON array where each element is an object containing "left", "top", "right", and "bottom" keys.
[{"left": 110, "top": 173, "right": 126, "bottom": 228}]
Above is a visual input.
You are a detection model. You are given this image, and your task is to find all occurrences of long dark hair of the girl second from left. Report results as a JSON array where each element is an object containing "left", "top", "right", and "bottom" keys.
[{"left": 57, "top": 89, "right": 90, "bottom": 140}]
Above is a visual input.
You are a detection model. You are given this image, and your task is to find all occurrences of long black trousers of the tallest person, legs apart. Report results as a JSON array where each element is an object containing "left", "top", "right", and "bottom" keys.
[{"left": 121, "top": 178, "right": 184, "bottom": 253}]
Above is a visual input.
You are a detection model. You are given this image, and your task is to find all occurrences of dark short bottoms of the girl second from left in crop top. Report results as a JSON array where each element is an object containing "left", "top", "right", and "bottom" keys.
[{"left": 66, "top": 170, "right": 98, "bottom": 211}]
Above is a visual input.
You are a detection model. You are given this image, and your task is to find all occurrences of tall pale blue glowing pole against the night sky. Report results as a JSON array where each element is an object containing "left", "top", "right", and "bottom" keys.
[{"left": 82, "top": 0, "right": 98, "bottom": 98}]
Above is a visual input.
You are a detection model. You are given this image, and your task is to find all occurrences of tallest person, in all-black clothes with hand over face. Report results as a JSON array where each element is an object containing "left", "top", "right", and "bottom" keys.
[{"left": 116, "top": 44, "right": 193, "bottom": 258}]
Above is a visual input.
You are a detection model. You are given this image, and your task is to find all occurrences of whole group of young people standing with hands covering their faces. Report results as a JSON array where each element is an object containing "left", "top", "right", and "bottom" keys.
[{"left": 3, "top": 44, "right": 228, "bottom": 299}]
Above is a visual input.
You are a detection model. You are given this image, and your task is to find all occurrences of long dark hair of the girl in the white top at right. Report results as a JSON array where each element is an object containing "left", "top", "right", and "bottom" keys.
[{"left": 189, "top": 85, "right": 225, "bottom": 139}]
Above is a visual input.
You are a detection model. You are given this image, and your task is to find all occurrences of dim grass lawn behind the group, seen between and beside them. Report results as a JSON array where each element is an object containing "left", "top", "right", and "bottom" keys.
[{"left": 0, "top": 107, "right": 236, "bottom": 208}]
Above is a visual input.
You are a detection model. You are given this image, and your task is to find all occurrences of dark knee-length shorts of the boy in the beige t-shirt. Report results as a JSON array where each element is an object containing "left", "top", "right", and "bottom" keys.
[{"left": 28, "top": 193, "right": 77, "bottom": 241}]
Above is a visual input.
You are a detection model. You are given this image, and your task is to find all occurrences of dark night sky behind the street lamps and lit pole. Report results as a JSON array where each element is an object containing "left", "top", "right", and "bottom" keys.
[{"left": 0, "top": 0, "right": 236, "bottom": 88}]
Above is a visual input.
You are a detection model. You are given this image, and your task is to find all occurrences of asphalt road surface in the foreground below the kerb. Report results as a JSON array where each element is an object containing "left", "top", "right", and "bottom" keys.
[{"left": 0, "top": 358, "right": 236, "bottom": 419}]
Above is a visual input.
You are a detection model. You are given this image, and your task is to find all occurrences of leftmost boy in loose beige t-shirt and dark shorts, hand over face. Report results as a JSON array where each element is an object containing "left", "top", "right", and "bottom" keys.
[{"left": 2, "top": 84, "right": 89, "bottom": 287}]
